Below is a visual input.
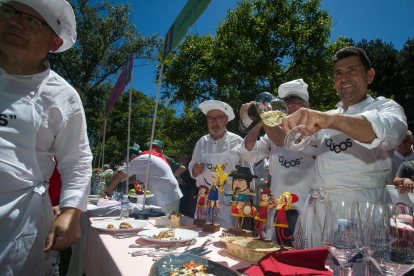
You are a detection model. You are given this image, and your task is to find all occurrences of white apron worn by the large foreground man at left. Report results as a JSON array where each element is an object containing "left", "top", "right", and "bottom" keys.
[{"left": 0, "top": 73, "right": 56, "bottom": 276}]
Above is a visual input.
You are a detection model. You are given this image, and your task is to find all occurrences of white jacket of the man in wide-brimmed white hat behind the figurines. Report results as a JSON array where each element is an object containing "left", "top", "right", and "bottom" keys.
[{"left": 188, "top": 131, "right": 255, "bottom": 184}]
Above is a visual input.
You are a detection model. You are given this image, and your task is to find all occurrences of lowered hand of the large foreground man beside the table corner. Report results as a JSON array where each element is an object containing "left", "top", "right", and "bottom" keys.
[{"left": 43, "top": 208, "right": 81, "bottom": 252}]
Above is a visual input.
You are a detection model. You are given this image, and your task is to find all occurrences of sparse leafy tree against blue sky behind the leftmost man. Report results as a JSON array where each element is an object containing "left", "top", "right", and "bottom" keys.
[{"left": 48, "top": 0, "right": 161, "bottom": 135}]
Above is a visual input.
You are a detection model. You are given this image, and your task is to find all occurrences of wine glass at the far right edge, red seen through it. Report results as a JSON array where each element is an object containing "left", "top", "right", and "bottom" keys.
[{"left": 367, "top": 203, "right": 414, "bottom": 275}]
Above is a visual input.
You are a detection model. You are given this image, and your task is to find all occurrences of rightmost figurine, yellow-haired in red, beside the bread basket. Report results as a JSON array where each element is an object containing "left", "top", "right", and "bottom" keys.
[{"left": 273, "top": 192, "right": 299, "bottom": 247}]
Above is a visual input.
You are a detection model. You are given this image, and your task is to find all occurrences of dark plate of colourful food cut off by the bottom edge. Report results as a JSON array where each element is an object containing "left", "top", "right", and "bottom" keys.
[{"left": 150, "top": 253, "right": 238, "bottom": 276}]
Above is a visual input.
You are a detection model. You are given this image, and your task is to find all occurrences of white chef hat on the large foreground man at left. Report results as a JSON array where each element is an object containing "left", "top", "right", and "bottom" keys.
[{"left": 2, "top": 0, "right": 76, "bottom": 53}]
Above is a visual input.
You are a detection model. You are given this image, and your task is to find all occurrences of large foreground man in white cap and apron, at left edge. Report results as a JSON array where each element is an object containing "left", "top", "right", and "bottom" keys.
[{"left": 0, "top": 0, "right": 92, "bottom": 275}]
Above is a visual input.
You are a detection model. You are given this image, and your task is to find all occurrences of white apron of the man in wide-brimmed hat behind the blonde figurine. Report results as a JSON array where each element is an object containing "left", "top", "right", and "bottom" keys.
[{"left": 197, "top": 132, "right": 236, "bottom": 229}]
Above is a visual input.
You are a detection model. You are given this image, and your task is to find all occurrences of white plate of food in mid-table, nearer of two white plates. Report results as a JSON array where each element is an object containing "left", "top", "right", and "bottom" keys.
[{"left": 138, "top": 228, "right": 198, "bottom": 243}]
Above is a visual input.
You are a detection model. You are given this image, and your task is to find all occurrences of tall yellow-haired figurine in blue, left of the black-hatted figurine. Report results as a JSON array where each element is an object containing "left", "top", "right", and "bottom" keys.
[{"left": 203, "top": 163, "right": 227, "bottom": 233}]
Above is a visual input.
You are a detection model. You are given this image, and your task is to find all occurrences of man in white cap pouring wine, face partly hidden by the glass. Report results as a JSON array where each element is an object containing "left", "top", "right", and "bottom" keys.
[{"left": 237, "top": 79, "right": 316, "bottom": 246}]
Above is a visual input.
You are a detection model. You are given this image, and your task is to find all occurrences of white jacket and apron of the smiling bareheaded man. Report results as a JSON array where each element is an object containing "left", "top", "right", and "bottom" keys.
[{"left": 294, "top": 95, "right": 408, "bottom": 249}]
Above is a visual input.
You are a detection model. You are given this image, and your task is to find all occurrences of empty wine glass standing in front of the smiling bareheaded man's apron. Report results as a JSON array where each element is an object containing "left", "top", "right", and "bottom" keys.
[{"left": 322, "top": 201, "right": 363, "bottom": 276}]
